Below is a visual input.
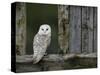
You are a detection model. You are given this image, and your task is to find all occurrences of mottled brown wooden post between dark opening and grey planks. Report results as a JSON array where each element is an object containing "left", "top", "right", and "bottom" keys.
[{"left": 58, "top": 5, "right": 69, "bottom": 54}]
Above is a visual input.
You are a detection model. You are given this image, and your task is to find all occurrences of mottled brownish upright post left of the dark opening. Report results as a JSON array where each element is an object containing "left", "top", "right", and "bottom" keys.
[{"left": 16, "top": 3, "right": 26, "bottom": 55}]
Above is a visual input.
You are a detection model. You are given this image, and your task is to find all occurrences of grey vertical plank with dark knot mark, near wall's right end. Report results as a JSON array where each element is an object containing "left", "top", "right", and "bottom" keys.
[{"left": 82, "top": 7, "right": 93, "bottom": 53}]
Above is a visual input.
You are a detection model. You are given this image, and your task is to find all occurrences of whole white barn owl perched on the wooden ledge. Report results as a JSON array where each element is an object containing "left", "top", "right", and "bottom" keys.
[{"left": 33, "top": 24, "right": 51, "bottom": 64}]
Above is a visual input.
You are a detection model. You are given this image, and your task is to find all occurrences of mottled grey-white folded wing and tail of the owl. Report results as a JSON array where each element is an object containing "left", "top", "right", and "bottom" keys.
[{"left": 33, "top": 35, "right": 46, "bottom": 64}]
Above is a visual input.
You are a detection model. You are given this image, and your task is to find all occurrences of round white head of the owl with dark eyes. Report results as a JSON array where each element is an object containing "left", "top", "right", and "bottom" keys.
[{"left": 38, "top": 24, "right": 51, "bottom": 35}]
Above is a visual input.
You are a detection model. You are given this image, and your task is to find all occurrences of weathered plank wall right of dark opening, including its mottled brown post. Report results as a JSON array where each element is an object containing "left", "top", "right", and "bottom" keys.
[{"left": 58, "top": 5, "right": 97, "bottom": 53}]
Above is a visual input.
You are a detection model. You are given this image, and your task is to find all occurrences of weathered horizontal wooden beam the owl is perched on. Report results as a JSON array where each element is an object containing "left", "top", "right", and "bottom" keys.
[{"left": 16, "top": 53, "right": 97, "bottom": 63}]
